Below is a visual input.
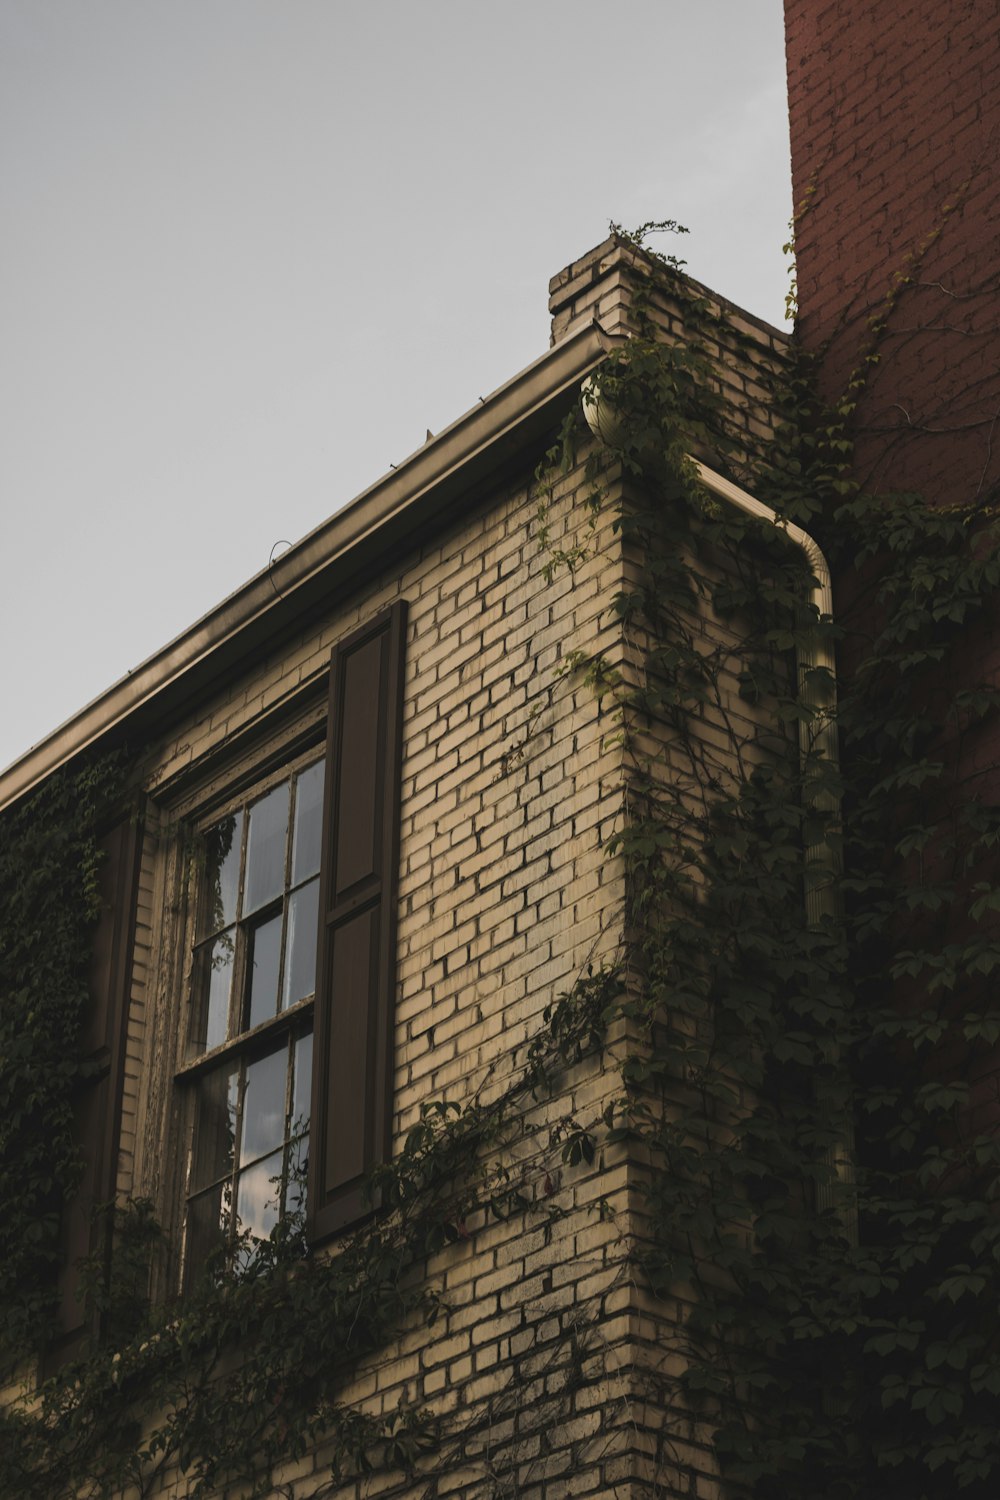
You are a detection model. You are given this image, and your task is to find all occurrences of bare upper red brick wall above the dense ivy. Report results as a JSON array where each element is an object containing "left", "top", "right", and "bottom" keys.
[{"left": 786, "top": 0, "right": 1000, "bottom": 501}]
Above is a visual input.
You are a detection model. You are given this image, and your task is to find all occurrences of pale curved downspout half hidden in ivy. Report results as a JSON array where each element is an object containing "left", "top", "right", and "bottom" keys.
[{"left": 582, "top": 393, "right": 858, "bottom": 1244}]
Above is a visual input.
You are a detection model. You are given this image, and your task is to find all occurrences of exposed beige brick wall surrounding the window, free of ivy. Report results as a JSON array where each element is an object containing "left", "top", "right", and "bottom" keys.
[{"left": 58, "top": 242, "right": 797, "bottom": 1500}]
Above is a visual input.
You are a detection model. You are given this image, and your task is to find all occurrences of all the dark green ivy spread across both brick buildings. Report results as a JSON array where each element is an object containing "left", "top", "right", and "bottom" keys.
[{"left": 0, "top": 224, "right": 1000, "bottom": 1500}]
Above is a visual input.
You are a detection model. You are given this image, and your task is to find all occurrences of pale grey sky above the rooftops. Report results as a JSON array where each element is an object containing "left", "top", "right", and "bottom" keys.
[{"left": 0, "top": 0, "right": 792, "bottom": 768}]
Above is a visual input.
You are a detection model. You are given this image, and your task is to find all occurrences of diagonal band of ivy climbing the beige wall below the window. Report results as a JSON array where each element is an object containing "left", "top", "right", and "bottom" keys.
[{"left": 0, "top": 942, "right": 618, "bottom": 1500}]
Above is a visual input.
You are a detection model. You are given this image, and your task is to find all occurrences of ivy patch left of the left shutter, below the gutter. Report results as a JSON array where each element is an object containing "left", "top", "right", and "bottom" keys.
[{"left": 0, "top": 755, "right": 131, "bottom": 1373}]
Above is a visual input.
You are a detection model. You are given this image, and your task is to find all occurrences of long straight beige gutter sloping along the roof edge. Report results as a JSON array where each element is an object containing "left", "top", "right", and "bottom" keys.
[{"left": 0, "top": 321, "right": 625, "bottom": 810}]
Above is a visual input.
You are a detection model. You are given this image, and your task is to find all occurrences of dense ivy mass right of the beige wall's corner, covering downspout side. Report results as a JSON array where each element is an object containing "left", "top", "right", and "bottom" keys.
[{"left": 563, "top": 225, "right": 1000, "bottom": 1500}]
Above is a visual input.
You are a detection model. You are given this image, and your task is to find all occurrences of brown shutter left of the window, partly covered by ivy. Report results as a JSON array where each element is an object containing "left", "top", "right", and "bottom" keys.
[{"left": 48, "top": 818, "right": 139, "bottom": 1365}]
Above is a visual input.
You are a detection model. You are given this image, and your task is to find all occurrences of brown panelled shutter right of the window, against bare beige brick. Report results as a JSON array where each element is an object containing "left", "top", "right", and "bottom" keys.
[{"left": 309, "top": 600, "right": 406, "bottom": 1239}]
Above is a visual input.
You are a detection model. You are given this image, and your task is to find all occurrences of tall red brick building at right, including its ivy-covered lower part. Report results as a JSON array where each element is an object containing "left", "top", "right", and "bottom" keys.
[{"left": 784, "top": 0, "right": 1000, "bottom": 1497}]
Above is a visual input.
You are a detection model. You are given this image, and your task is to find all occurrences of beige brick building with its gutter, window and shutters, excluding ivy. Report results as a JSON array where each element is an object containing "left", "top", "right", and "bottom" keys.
[{"left": 0, "top": 240, "right": 817, "bottom": 1497}]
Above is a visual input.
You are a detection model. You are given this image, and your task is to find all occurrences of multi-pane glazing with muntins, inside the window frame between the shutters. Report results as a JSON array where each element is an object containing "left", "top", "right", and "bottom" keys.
[{"left": 184, "top": 761, "right": 324, "bottom": 1280}]
